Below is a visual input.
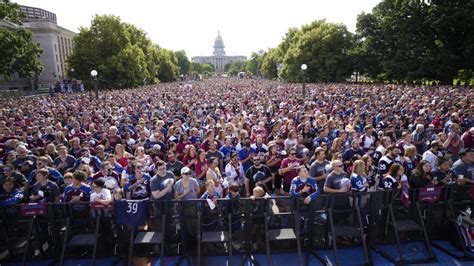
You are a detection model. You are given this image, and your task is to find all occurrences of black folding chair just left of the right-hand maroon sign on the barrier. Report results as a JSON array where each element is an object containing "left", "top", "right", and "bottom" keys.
[{"left": 376, "top": 190, "right": 436, "bottom": 264}]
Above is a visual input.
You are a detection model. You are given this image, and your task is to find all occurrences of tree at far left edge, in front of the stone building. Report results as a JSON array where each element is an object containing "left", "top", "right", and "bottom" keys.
[{"left": 0, "top": 0, "right": 43, "bottom": 80}]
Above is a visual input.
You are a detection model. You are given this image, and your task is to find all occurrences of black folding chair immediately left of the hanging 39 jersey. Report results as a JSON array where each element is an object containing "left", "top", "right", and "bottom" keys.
[{"left": 59, "top": 203, "right": 100, "bottom": 265}]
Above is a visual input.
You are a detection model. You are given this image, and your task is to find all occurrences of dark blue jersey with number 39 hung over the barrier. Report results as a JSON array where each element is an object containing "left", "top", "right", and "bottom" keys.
[{"left": 115, "top": 200, "right": 146, "bottom": 226}]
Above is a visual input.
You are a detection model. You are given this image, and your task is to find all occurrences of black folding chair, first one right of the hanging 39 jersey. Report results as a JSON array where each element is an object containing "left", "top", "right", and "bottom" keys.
[{"left": 197, "top": 198, "right": 232, "bottom": 265}]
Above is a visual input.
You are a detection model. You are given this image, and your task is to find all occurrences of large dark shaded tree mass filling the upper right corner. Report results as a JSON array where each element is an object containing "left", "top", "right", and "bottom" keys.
[{"left": 353, "top": 0, "right": 474, "bottom": 84}]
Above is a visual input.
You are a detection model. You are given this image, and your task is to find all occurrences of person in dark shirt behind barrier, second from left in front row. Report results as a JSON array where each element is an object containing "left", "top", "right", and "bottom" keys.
[{"left": 30, "top": 168, "right": 61, "bottom": 203}]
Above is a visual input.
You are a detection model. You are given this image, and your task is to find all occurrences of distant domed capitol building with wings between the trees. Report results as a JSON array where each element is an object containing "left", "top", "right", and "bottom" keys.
[{"left": 192, "top": 32, "right": 247, "bottom": 74}]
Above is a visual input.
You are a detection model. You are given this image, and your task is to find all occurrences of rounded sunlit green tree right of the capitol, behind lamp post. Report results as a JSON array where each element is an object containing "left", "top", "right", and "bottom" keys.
[{"left": 262, "top": 20, "right": 354, "bottom": 82}]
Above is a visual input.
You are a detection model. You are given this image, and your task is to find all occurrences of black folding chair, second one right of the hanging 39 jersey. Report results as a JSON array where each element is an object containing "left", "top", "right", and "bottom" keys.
[{"left": 263, "top": 196, "right": 303, "bottom": 266}]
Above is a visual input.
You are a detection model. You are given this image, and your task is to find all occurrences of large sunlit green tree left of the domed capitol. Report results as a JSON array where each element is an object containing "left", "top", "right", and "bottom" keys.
[{"left": 68, "top": 15, "right": 178, "bottom": 88}]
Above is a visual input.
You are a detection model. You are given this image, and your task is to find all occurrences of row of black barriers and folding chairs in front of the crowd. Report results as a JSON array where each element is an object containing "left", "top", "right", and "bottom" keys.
[{"left": 0, "top": 185, "right": 474, "bottom": 265}]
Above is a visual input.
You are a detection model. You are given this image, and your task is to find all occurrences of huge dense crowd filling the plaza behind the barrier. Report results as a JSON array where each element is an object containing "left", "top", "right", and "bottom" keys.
[{"left": 0, "top": 79, "right": 474, "bottom": 209}]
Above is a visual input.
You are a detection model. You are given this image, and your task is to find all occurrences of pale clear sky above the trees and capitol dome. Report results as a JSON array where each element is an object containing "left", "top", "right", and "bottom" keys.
[{"left": 12, "top": 0, "right": 380, "bottom": 57}]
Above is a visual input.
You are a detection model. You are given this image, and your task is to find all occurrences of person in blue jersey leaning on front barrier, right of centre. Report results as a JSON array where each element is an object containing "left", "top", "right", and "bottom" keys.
[{"left": 290, "top": 167, "right": 321, "bottom": 205}]
